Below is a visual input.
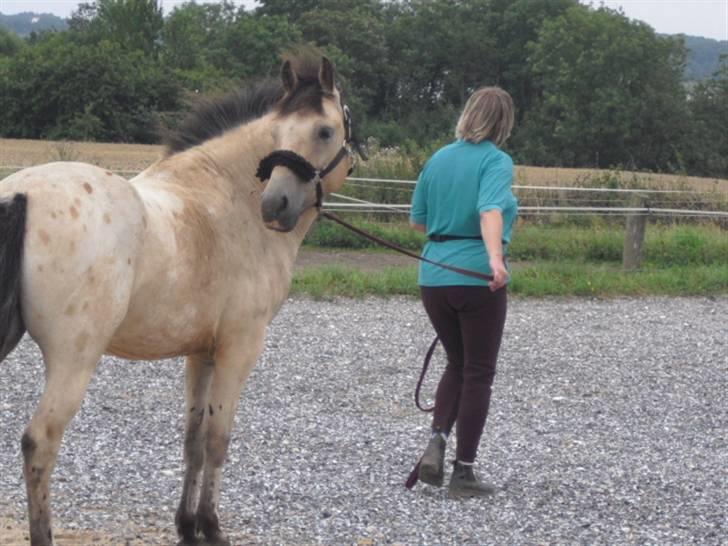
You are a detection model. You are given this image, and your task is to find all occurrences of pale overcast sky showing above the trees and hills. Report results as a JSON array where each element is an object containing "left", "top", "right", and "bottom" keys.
[{"left": 0, "top": 0, "right": 728, "bottom": 40}]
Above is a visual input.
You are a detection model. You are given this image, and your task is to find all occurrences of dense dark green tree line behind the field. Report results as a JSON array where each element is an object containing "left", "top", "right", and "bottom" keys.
[{"left": 0, "top": 0, "right": 728, "bottom": 178}]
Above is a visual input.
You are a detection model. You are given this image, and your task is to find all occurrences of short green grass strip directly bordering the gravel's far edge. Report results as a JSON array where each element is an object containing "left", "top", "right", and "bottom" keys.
[{"left": 291, "top": 261, "right": 728, "bottom": 298}]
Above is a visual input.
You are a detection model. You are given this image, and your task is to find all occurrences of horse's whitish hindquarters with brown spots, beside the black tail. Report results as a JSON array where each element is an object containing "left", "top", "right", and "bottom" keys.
[{"left": 0, "top": 162, "right": 144, "bottom": 352}]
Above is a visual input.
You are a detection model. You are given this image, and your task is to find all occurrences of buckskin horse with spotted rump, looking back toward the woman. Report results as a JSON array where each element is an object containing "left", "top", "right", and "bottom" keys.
[{"left": 0, "top": 51, "right": 354, "bottom": 546}]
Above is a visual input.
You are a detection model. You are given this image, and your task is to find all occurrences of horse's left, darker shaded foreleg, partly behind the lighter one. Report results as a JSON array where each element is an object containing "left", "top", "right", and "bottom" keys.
[{"left": 175, "top": 356, "right": 213, "bottom": 546}]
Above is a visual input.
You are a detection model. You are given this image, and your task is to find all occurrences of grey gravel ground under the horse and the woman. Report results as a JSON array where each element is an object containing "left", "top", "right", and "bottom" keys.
[{"left": 0, "top": 297, "right": 728, "bottom": 545}]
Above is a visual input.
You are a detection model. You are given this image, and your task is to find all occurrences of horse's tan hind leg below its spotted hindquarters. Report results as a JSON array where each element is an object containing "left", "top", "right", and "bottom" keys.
[{"left": 21, "top": 353, "right": 101, "bottom": 546}]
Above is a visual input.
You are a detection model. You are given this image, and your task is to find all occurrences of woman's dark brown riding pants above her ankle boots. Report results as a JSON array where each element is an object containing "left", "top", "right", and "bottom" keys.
[{"left": 421, "top": 286, "right": 507, "bottom": 462}]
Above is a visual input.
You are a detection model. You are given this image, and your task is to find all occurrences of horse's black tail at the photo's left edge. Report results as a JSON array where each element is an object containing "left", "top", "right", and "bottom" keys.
[{"left": 0, "top": 193, "right": 28, "bottom": 362}]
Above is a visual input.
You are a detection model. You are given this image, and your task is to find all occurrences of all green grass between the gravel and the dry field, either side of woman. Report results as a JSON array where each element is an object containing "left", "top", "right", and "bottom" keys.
[{"left": 292, "top": 221, "right": 728, "bottom": 298}]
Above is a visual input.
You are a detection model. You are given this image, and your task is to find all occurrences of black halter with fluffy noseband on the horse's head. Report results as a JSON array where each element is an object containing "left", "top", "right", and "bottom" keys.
[{"left": 255, "top": 98, "right": 354, "bottom": 209}]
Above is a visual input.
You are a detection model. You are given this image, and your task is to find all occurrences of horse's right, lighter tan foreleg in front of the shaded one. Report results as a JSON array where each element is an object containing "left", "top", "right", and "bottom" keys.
[{"left": 197, "top": 330, "right": 264, "bottom": 546}]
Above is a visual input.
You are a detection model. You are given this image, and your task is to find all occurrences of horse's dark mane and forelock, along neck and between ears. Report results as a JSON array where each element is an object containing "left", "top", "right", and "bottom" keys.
[{"left": 163, "top": 50, "right": 326, "bottom": 156}]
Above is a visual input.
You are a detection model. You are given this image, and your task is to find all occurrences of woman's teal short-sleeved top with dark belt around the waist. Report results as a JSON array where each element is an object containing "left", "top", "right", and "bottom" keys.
[{"left": 410, "top": 140, "right": 518, "bottom": 286}]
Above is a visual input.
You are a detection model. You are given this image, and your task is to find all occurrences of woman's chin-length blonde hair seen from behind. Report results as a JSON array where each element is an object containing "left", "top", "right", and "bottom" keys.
[{"left": 455, "top": 87, "right": 515, "bottom": 146}]
